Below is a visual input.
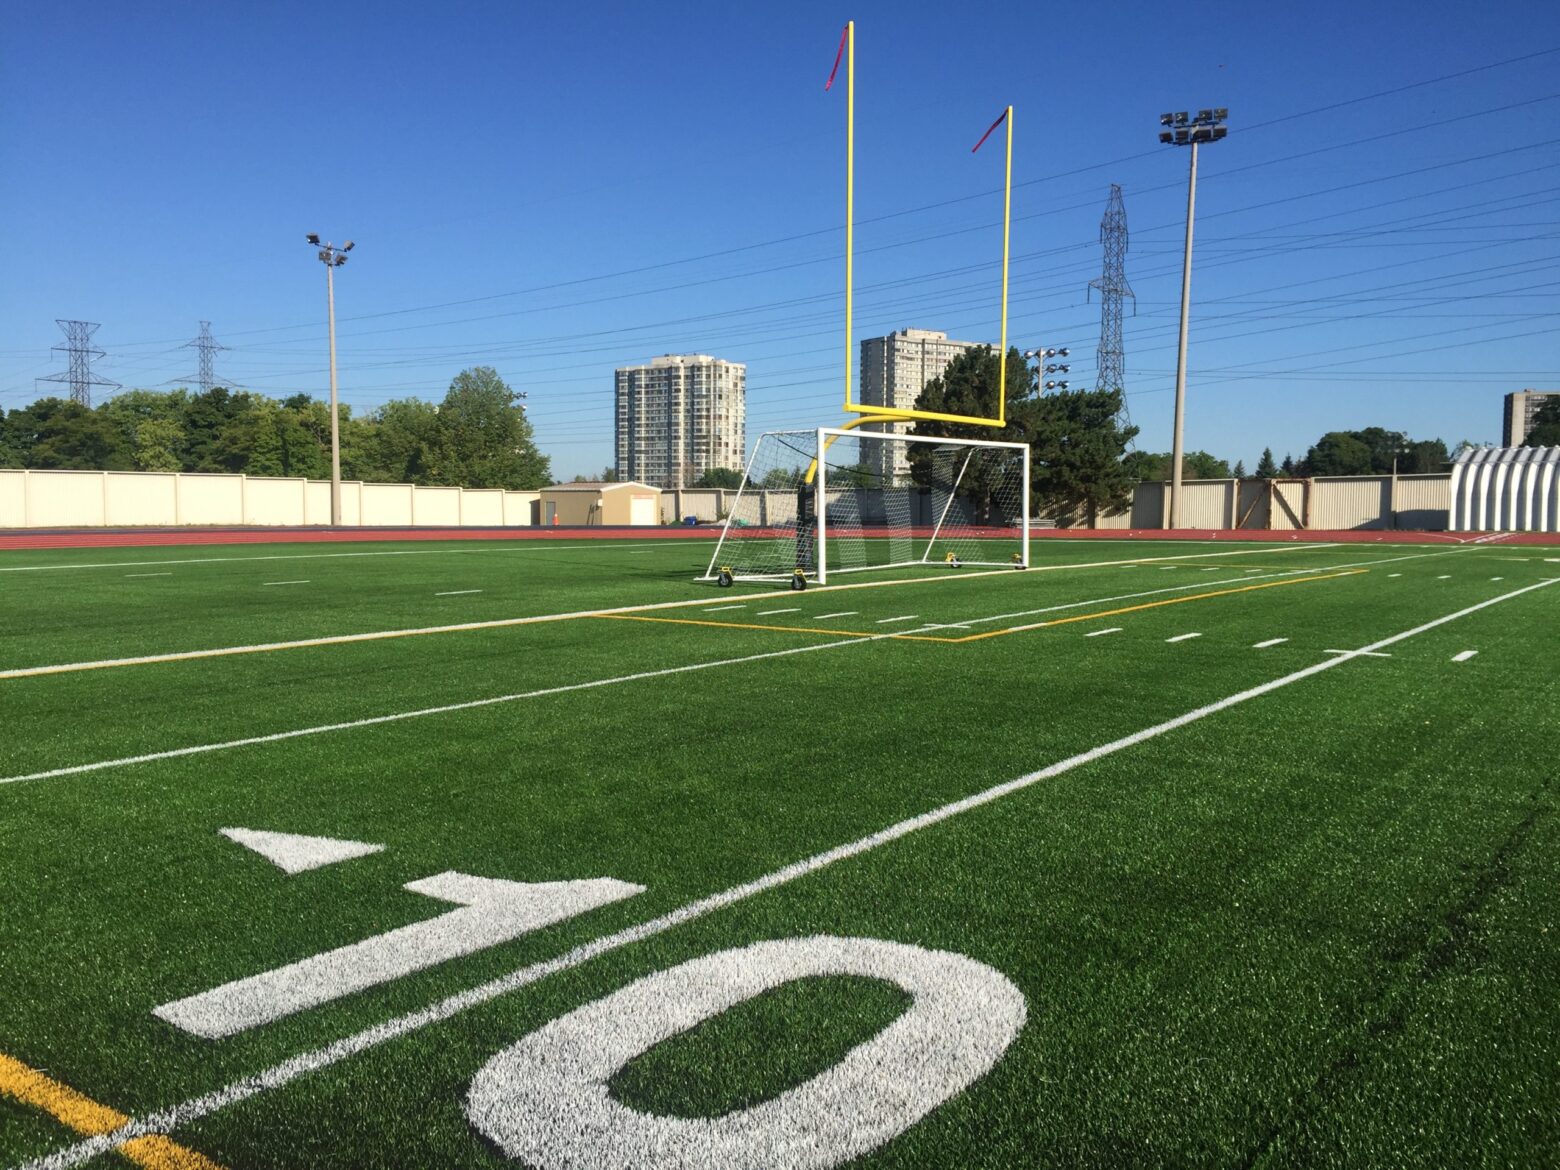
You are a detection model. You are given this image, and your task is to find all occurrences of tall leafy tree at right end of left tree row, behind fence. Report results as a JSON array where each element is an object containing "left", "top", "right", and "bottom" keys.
[{"left": 438, "top": 365, "right": 552, "bottom": 490}]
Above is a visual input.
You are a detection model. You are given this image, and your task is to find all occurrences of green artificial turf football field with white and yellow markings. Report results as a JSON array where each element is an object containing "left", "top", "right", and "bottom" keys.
[{"left": 0, "top": 538, "right": 1560, "bottom": 1170}]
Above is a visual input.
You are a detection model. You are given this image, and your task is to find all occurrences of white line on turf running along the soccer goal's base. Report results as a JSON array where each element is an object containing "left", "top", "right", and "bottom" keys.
[{"left": 0, "top": 544, "right": 1341, "bottom": 680}]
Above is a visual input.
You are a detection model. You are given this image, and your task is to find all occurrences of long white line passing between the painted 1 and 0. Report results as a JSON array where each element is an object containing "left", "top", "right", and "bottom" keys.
[{"left": 19, "top": 577, "right": 1560, "bottom": 1170}]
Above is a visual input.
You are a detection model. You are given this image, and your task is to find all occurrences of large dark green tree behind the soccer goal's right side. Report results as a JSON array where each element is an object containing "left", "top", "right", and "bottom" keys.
[{"left": 911, "top": 346, "right": 1137, "bottom": 523}]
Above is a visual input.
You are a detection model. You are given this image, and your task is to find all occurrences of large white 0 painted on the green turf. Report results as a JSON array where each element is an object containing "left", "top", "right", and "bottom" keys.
[{"left": 466, "top": 936, "right": 1025, "bottom": 1170}]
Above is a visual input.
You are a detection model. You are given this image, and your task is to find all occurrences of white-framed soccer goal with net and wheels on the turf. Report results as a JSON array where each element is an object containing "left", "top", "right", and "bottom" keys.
[{"left": 700, "top": 427, "right": 1030, "bottom": 590}]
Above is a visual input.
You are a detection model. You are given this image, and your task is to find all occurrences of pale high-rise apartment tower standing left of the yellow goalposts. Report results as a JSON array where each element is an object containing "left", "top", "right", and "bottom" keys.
[{"left": 616, "top": 354, "right": 747, "bottom": 488}]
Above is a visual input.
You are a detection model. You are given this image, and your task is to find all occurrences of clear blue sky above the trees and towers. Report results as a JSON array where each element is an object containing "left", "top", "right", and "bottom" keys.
[{"left": 0, "top": 0, "right": 1560, "bottom": 477}]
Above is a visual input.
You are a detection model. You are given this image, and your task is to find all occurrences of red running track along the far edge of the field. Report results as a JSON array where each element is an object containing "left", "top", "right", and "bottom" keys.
[{"left": 0, "top": 524, "right": 1560, "bottom": 549}]
